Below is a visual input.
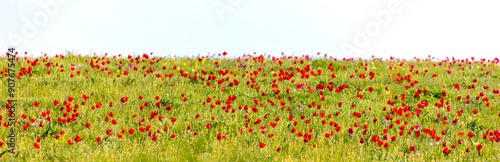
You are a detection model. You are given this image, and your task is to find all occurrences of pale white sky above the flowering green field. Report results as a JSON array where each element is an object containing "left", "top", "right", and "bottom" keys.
[{"left": 0, "top": 0, "right": 500, "bottom": 58}]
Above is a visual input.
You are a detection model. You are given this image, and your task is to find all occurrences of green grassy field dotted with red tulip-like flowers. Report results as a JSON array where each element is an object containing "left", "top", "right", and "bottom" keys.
[{"left": 0, "top": 53, "right": 500, "bottom": 161}]
